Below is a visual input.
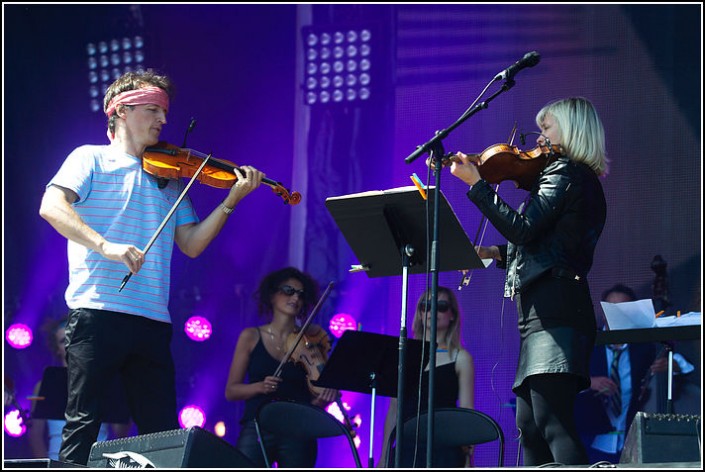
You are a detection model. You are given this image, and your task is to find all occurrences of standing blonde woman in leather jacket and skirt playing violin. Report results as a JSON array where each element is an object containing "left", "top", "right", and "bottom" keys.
[{"left": 450, "top": 98, "right": 608, "bottom": 466}]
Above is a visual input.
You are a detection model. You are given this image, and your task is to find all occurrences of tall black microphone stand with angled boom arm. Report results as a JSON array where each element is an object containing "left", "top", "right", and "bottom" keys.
[{"left": 404, "top": 78, "right": 515, "bottom": 468}]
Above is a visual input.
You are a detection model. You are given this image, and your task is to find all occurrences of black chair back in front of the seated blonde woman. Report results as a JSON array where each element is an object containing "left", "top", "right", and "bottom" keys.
[{"left": 387, "top": 408, "right": 504, "bottom": 467}]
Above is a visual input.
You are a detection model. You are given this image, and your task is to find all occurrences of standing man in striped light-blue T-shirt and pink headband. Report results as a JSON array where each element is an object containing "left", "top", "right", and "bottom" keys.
[{"left": 39, "top": 71, "right": 263, "bottom": 464}]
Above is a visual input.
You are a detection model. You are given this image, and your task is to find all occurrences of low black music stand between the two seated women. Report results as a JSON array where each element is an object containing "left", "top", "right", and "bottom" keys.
[{"left": 311, "top": 330, "right": 428, "bottom": 468}]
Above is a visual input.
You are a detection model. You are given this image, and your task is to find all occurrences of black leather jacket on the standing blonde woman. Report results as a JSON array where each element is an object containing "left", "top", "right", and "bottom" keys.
[{"left": 467, "top": 156, "right": 607, "bottom": 297}]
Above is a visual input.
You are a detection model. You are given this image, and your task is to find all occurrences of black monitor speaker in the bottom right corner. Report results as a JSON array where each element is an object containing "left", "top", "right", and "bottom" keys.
[{"left": 619, "top": 411, "right": 702, "bottom": 464}]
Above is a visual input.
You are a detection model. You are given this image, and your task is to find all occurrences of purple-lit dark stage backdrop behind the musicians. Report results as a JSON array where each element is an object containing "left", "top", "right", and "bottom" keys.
[{"left": 3, "top": 4, "right": 702, "bottom": 467}]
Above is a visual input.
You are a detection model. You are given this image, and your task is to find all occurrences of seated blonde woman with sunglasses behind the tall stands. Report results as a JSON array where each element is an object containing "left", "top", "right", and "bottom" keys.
[{"left": 379, "top": 287, "right": 475, "bottom": 468}]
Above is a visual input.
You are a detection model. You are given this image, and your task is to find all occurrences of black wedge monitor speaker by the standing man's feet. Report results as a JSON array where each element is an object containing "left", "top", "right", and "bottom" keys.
[{"left": 88, "top": 426, "right": 254, "bottom": 469}]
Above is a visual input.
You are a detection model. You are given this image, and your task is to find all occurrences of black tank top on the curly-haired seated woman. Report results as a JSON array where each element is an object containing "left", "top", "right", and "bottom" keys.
[{"left": 240, "top": 327, "right": 313, "bottom": 423}]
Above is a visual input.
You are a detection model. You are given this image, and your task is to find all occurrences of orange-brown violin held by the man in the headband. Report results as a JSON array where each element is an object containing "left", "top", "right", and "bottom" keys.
[{"left": 142, "top": 141, "right": 301, "bottom": 205}]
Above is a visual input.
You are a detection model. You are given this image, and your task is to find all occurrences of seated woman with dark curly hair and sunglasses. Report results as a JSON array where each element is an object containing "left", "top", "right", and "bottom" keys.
[{"left": 225, "top": 267, "right": 338, "bottom": 468}]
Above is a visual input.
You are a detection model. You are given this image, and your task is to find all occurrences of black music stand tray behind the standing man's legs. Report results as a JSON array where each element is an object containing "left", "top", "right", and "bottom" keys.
[{"left": 32, "top": 366, "right": 130, "bottom": 424}]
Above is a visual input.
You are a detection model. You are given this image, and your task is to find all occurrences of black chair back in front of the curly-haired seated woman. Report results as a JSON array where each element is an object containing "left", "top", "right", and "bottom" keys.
[{"left": 255, "top": 401, "right": 362, "bottom": 468}]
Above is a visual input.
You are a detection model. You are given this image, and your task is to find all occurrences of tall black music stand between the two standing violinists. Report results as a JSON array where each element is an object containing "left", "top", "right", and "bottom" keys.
[{"left": 326, "top": 186, "right": 485, "bottom": 466}]
